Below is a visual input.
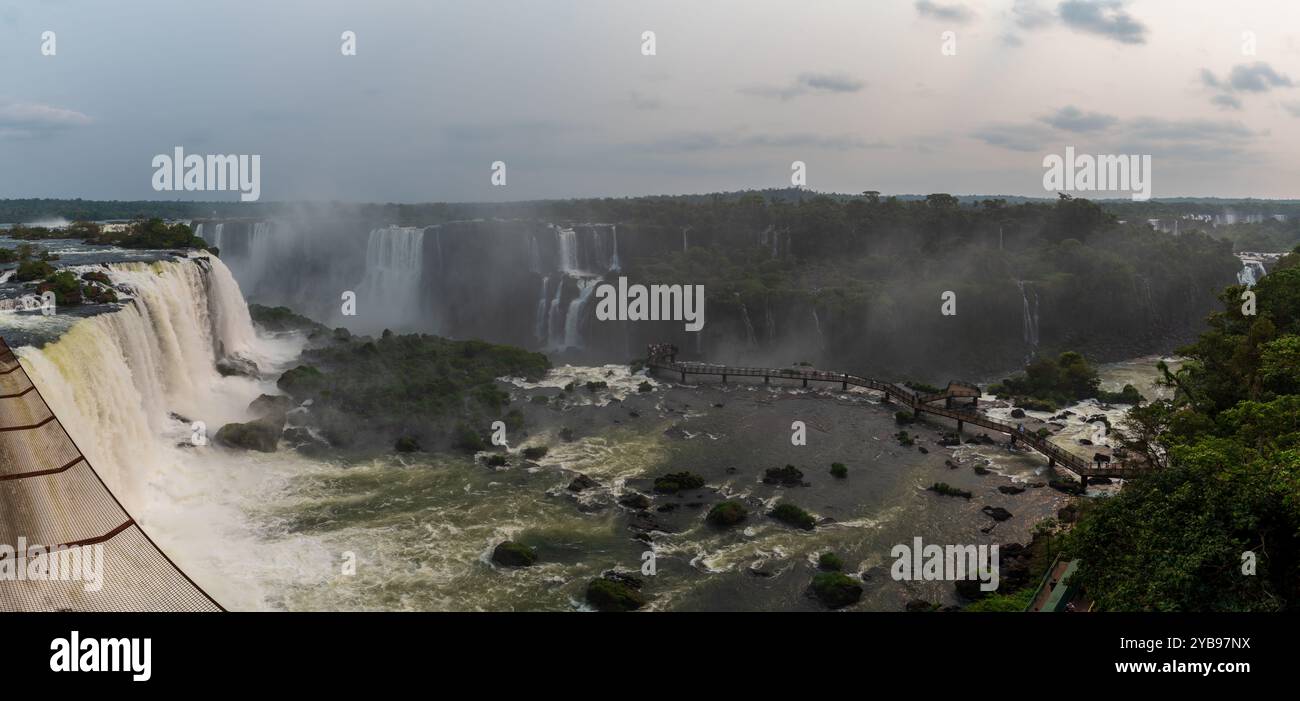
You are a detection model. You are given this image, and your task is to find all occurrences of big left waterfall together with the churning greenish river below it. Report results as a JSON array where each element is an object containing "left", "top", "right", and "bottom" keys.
[{"left": 2, "top": 249, "right": 1170, "bottom": 610}]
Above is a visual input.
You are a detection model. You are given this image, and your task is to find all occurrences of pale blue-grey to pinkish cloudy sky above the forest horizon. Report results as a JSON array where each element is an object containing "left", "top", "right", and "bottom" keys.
[{"left": 0, "top": 0, "right": 1300, "bottom": 202}]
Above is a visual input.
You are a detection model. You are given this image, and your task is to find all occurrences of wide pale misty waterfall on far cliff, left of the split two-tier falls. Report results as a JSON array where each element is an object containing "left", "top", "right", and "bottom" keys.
[{"left": 356, "top": 226, "right": 424, "bottom": 332}]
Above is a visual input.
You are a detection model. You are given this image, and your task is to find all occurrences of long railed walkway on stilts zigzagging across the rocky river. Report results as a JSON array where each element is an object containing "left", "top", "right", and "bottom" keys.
[{"left": 646, "top": 345, "right": 1145, "bottom": 483}]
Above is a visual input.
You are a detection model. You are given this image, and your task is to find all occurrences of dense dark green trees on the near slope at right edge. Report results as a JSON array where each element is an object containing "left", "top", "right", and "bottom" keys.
[{"left": 1069, "top": 245, "right": 1300, "bottom": 611}]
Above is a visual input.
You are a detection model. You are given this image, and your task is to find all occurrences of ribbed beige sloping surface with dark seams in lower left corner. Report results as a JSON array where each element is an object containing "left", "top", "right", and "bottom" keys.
[{"left": 0, "top": 338, "right": 224, "bottom": 611}]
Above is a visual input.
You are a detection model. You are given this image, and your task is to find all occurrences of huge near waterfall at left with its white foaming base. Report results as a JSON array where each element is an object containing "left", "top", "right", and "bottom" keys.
[{"left": 18, "top": 259, "right": 315, "bottom": 609}]
